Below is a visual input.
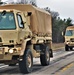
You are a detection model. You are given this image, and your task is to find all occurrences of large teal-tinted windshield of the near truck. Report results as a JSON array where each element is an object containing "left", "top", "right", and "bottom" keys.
[{"left": 0, "top": 12, "right": 16, "bottom": 30}]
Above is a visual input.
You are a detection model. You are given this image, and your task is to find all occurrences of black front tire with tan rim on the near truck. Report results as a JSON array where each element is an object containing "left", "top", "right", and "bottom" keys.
[{"left": 19, "top": 49, "right": 33, "bottom": 74}]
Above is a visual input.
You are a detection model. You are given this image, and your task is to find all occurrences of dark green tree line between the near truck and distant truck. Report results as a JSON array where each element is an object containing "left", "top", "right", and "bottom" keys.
[{"left": 44, "top": 7, "right": 73, "bottom": 43}]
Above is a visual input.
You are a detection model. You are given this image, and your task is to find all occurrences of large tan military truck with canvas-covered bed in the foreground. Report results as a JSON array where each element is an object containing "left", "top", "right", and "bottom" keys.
[{"left": 0, "top": 4, "right": 53, "bottom": 73}]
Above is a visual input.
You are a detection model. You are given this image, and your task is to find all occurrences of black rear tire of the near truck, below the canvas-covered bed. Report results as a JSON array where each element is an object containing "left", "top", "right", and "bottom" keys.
[{"left": 40, "top": 46, "right": 50, "bottom": 66}]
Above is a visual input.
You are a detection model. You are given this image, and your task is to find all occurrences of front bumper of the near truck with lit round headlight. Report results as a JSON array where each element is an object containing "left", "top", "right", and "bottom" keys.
[{"left": 0, "top": 47, "right": 20, "bottom": 63}]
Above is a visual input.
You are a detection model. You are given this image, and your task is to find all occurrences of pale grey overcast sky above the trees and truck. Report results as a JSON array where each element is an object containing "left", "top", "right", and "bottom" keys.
[{"left": 2, "top": 0, "right": 74, "bottom": 20}]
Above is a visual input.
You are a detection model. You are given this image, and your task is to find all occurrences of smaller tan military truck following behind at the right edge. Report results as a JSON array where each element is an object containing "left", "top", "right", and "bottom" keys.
[{"left": 65, "top": 26, "right": 74, "bottom": 51}]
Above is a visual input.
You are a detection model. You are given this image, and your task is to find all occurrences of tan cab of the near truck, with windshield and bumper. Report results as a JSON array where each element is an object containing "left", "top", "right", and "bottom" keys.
[{"left": 0, "top": 9, "right": 31, "bottom": 63}]
